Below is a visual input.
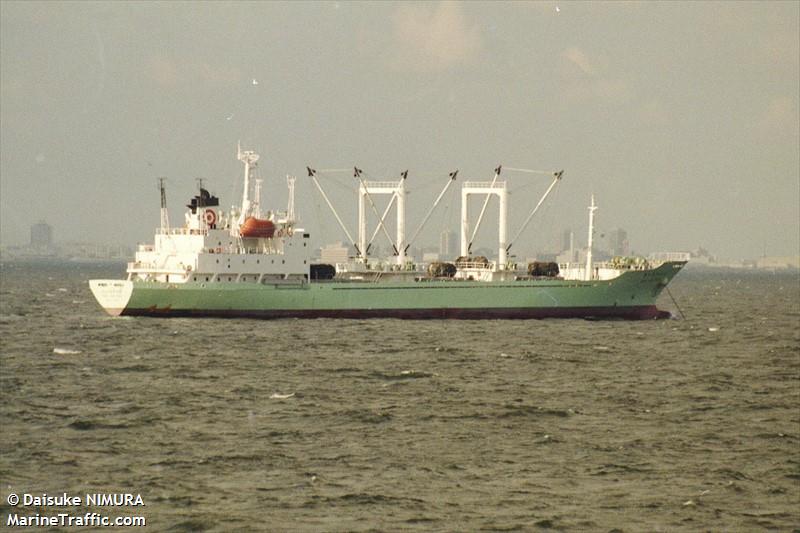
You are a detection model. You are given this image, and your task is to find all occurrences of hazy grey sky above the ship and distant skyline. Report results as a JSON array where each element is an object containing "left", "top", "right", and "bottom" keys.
[{"left": 0, "top": 1, "right": 800, "bottom": 258}]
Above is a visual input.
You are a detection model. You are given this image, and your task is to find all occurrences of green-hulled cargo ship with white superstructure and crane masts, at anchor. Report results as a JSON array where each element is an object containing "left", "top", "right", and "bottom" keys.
[{"left": 89, "top": 147, "right": 685, "bottom": 319}]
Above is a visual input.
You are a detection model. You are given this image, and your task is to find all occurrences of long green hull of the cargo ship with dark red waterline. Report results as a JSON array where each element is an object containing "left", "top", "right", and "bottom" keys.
[{"left": 107, "top": 262, "right": 685, "bottom": 319}]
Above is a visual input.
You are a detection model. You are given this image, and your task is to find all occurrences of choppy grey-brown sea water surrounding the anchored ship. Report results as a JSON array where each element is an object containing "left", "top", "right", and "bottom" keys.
[{"left": 0, "top": 263, "right": 800, "bottom": 531}]
